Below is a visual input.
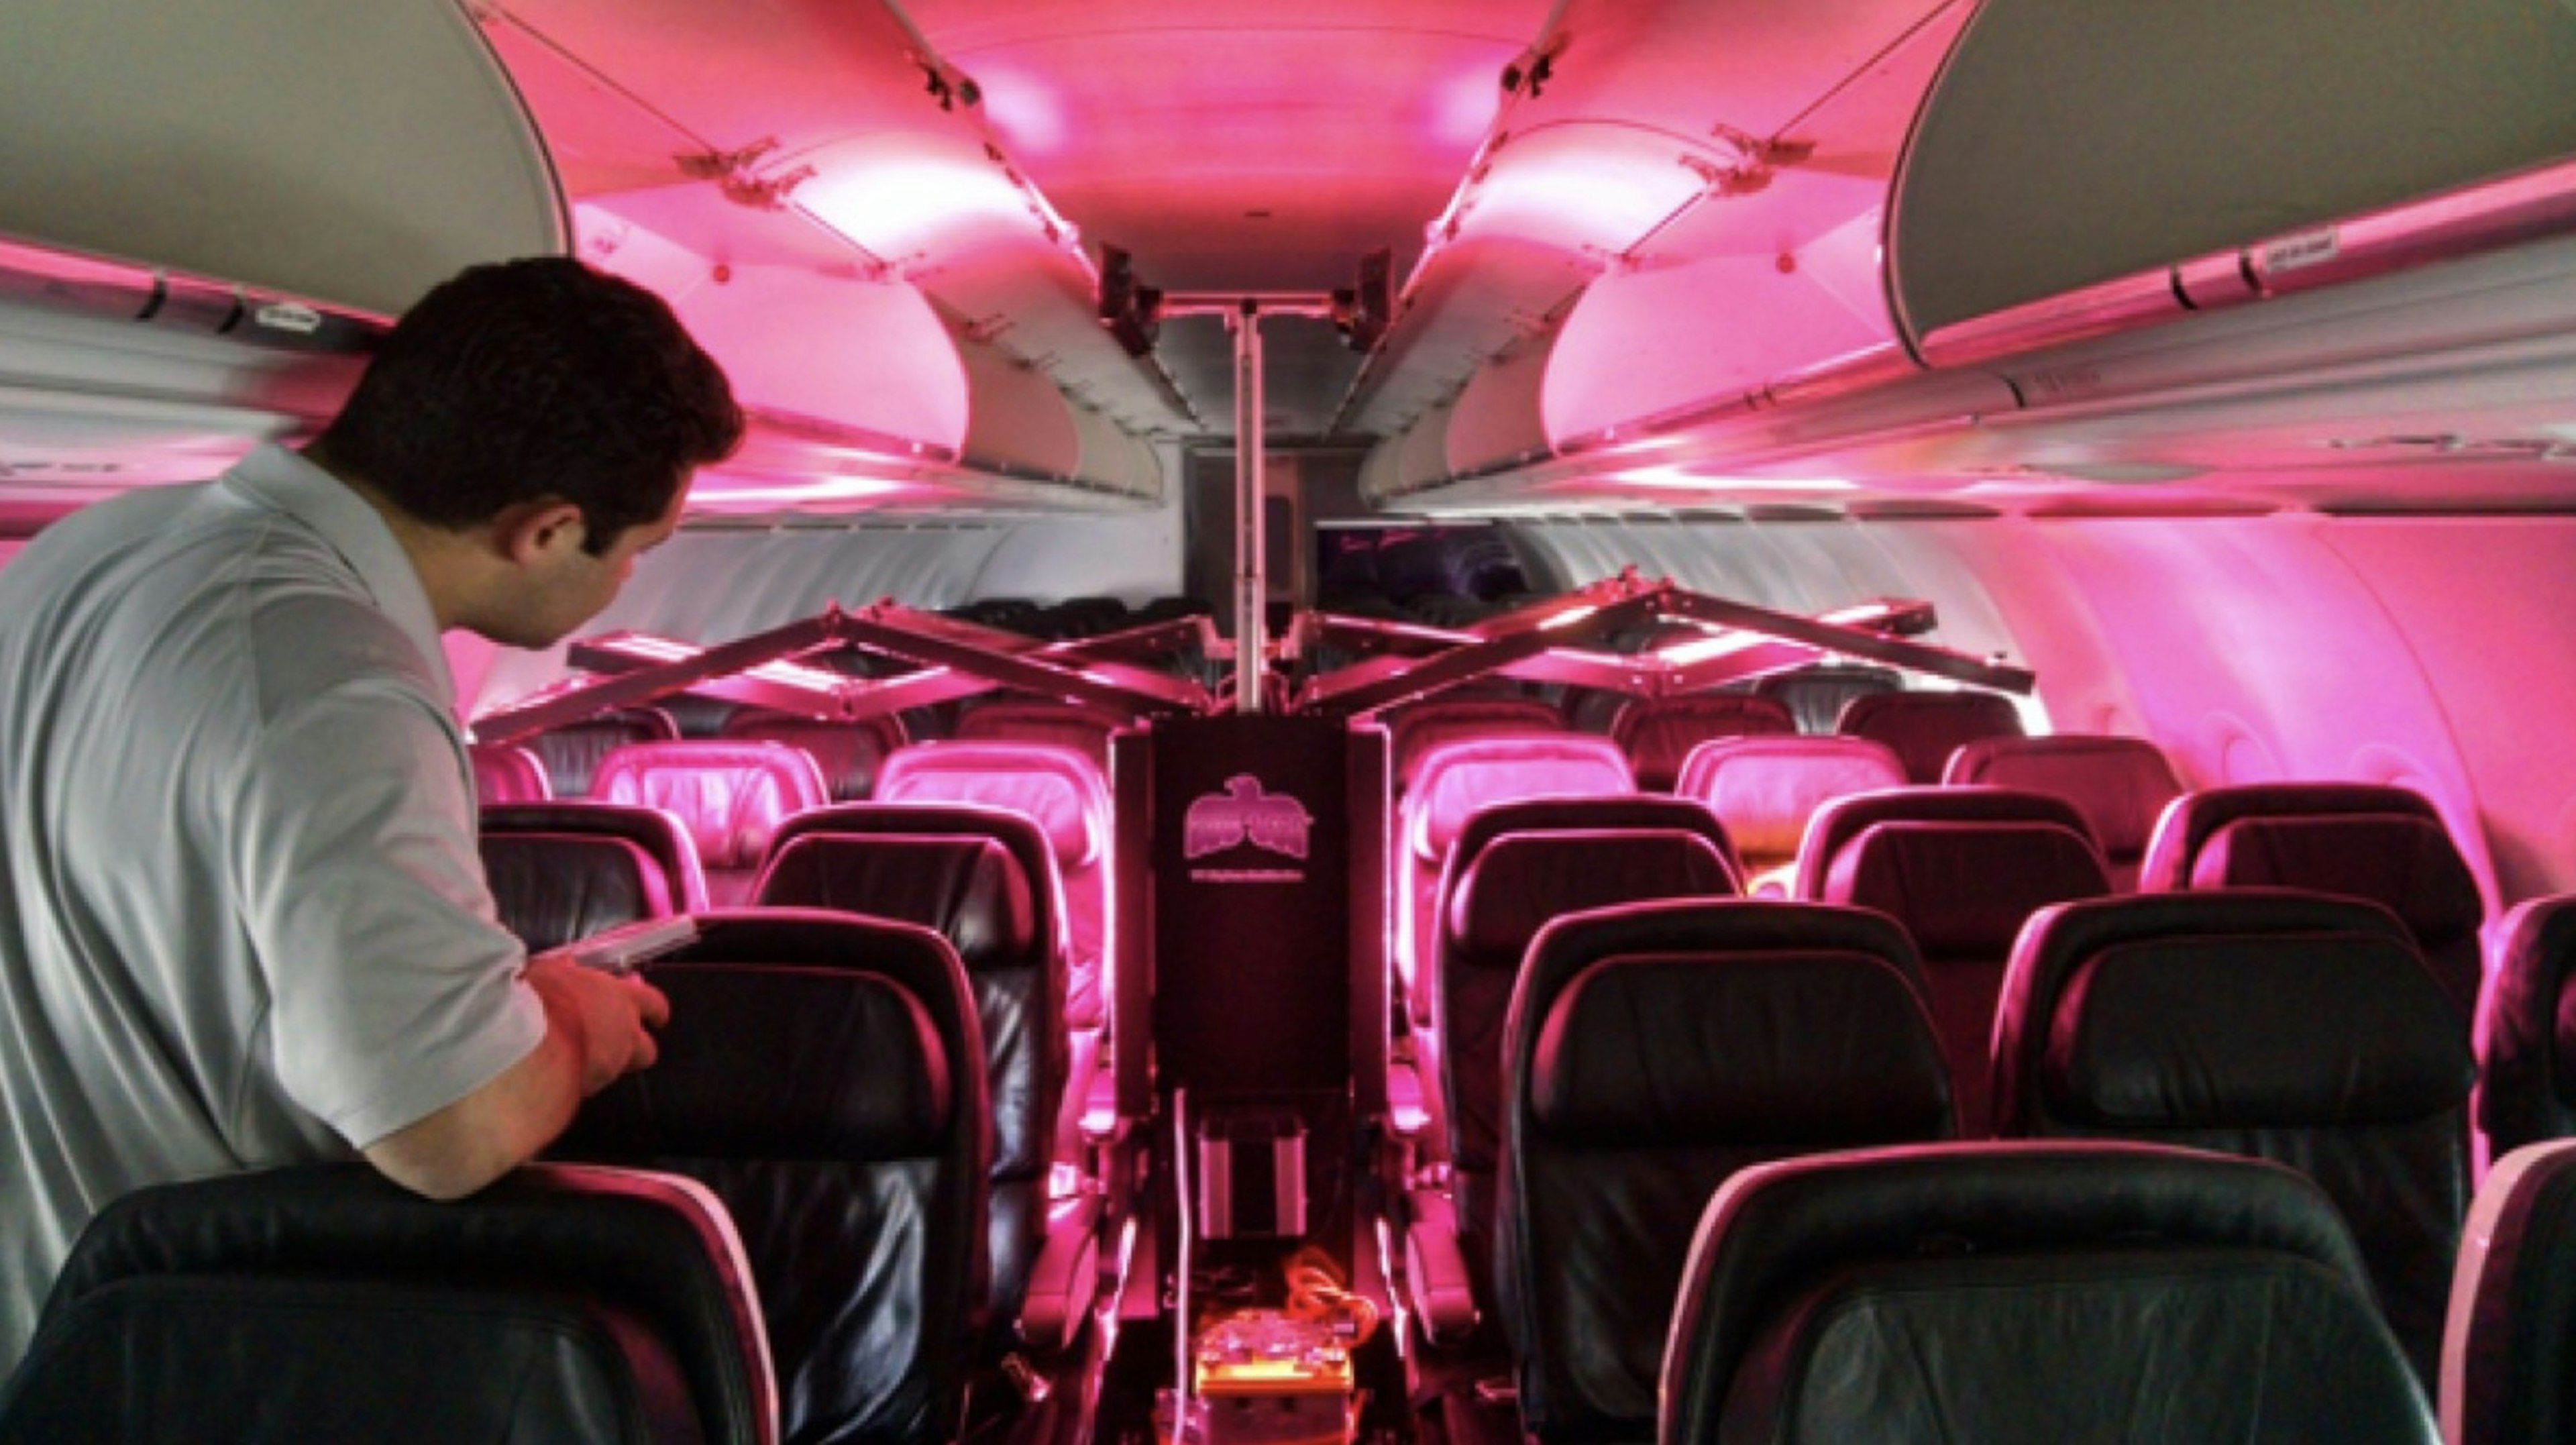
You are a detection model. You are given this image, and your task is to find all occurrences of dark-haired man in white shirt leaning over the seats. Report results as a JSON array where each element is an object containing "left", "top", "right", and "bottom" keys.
[{"left": 0, "top": 260, "right": 742, "bottom": 1373}]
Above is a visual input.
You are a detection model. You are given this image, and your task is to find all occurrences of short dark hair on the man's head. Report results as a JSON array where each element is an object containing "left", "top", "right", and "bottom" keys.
[{"left": 314, "top": 258, "right": 742, "bottom": 554}]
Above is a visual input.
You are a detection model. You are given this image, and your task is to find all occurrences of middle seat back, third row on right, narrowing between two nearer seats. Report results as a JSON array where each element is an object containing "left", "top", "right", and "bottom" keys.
[{"left": 1798, "top": 788, "right": 2110, "bottom": 1138}]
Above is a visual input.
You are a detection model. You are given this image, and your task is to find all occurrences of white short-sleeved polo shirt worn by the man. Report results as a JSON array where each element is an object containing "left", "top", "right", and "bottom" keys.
[{"left": 0, "top": 445, "right": 546, "bottom": 1373}]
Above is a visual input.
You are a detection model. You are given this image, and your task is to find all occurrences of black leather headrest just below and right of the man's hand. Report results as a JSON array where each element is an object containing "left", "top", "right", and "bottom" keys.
[{"left": 559, "top": 961, "right": 958, "bottom": 1164}]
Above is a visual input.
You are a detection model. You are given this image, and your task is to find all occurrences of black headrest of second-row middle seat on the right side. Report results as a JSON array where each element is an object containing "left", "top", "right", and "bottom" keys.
[{"left": 1996, "top": 891, "right": 2475, "bottom": 1131}]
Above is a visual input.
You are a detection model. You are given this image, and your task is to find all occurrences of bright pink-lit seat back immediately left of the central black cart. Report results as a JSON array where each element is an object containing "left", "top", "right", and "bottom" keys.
[{"left": 876, "top": 742, "right": 1113, "bottom": 1028}]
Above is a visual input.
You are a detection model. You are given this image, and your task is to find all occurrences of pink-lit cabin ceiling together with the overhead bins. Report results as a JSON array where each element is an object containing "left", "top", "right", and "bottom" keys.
[{"left": 0, "top": 0, "right": 2576, "bottom": 515}]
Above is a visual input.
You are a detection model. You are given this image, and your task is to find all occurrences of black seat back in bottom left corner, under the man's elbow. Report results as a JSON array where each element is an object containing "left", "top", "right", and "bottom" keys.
[{"left": 0, "top": 1164, "right": 778, "bottom": 1445}]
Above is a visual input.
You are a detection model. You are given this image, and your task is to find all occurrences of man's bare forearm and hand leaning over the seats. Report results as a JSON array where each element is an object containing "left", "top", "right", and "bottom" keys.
[{"left": 366, "top": 953, "right": 669, "bottom": 1200}]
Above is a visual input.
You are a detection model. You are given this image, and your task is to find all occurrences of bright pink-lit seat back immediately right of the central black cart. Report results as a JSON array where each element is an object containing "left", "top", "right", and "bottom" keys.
[{"left": 1396, "top": 731, "right": 1635, "bottom": 1025}]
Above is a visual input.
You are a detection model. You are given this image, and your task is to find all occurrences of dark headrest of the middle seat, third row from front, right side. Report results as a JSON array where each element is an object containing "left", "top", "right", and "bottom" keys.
[{"left": 1819, "top": 822, "right": 2110, "bottom": 958}]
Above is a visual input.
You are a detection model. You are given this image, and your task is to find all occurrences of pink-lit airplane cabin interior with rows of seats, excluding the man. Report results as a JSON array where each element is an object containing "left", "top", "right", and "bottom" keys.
[{"left": 0, "top": 0, "right": 2576, "bottom": 1445}]
